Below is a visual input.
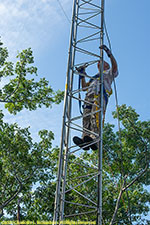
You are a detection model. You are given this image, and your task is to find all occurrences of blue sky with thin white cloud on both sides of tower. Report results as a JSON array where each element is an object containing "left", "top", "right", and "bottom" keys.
[{"left": 0, "top": 0, "right": 150, "bottom": 221}]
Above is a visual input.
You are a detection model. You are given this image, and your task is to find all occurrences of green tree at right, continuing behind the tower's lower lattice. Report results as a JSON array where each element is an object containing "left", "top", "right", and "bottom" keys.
[{"left": 54, "top": 105, "right": 150, "bottom": 225}]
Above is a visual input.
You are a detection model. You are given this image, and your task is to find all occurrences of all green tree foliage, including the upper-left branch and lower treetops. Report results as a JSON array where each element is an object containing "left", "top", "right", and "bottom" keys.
[{"left": 0, "top": 38, "right": 150, "bottom": 225}]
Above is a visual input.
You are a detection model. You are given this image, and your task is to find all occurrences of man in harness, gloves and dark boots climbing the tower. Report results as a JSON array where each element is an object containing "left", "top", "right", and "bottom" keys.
[{"left": 73, "top": 45, "right": 118, "bottom": 150}]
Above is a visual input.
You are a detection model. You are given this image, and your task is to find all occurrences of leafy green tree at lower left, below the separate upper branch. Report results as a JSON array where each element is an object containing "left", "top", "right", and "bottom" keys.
[{"left": 0, "top": 108, "right": 55, "bottom": 219}]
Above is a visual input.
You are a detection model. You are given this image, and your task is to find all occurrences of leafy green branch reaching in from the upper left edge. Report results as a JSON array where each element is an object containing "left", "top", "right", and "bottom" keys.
[{"left": 0, "top": 40, "right": 64, "bottom": 114}]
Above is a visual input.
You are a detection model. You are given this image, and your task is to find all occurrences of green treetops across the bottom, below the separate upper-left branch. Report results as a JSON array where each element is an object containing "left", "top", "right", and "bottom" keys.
[{"left": 0, "top": 105, "right": 150, "bottom": 225}]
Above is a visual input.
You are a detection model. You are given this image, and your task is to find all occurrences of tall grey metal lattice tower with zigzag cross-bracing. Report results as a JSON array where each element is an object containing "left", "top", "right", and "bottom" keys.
[{"left": 53, "top": 0, "right": 104, "bottom": 225}]
